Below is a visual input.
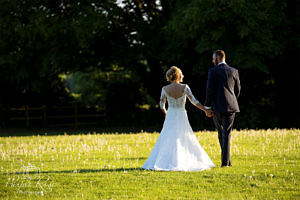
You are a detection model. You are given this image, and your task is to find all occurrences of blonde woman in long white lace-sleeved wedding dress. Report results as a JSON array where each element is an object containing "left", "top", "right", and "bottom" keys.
[{"left": 142, "top": 66, "right": 215, "bottom": 171}]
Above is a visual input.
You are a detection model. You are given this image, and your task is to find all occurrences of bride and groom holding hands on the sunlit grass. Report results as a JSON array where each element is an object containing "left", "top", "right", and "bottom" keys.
[{"left": 142, "top": 50, "right": 240, "bottom": 171}]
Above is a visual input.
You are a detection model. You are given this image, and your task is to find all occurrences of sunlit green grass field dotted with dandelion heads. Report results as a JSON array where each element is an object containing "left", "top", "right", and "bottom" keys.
[{"left": 0, "top": 129, "right": 300, "bottom": 199}]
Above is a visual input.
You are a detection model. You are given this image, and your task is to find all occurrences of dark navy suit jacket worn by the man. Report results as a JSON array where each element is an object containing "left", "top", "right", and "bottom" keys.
[{"left": 204, "top": 63, "right": 241, "bottom": 113}]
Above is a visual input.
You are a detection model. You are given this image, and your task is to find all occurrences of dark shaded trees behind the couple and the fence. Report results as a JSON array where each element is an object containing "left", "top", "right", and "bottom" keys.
[{"left": 0, "top": 0, "right": 300, "bottom": 128}]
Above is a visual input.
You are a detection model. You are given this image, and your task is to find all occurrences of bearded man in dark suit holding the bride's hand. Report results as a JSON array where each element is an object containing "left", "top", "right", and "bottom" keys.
[{"left": 204, "top": 50, "right": 241, "bottom": 167}]
